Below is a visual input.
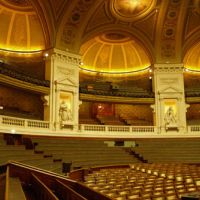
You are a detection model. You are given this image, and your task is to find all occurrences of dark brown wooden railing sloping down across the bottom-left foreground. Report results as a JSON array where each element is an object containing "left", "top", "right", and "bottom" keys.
[{"left": 0, "top": 161, "right": 110, "bottom": 200}]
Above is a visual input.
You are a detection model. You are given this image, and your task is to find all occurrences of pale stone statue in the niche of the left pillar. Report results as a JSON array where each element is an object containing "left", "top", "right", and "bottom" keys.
[{"left": 59, "top": 100, "right": 72, "bottom": 124}]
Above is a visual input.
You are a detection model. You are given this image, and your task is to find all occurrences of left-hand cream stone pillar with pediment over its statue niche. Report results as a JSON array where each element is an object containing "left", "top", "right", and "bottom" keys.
[{"left": 46, "top": 49, "right": 80, "bottom": 130}]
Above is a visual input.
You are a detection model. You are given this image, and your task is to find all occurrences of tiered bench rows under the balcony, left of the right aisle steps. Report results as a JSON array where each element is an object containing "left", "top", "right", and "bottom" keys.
[{"left": 0, "top": 135, "right": 140, "bottom": 174}]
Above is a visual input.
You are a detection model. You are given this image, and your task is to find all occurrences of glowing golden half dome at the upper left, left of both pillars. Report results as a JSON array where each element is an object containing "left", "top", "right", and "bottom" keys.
[{"left": 0, "top": 0, "right": 45, "bottom": 52}]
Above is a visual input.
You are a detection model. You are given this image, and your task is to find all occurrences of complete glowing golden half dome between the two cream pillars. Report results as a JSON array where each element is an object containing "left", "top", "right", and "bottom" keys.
[{"left": 80, "top": 32, "right": 151, "bottom": 73}]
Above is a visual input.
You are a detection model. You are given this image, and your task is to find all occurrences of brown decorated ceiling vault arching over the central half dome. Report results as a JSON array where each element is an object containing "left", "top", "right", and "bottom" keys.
[{"left": 56, "top": 0, "right": 200, "bottom": 72}]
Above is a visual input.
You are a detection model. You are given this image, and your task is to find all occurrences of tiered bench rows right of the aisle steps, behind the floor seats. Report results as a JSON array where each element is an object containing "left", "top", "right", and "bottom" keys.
[{"left": 132, "top": 138, "right": 200, "bottom": 163}]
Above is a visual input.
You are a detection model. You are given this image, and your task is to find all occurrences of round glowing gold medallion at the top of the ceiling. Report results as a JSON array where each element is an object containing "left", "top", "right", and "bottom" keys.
[{"left": 110, "top": 0, "right": 157, "bottom": 21}]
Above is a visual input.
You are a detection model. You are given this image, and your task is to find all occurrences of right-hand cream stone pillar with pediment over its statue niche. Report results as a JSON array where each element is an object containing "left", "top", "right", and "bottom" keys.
[{"left": 154, "top": 63, "right": 187, "bottom": 133}]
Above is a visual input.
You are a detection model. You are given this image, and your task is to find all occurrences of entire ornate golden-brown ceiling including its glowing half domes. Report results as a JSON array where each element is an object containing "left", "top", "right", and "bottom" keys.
[{"left": 0, "top": 0, "right": 200, "bottom": 73}]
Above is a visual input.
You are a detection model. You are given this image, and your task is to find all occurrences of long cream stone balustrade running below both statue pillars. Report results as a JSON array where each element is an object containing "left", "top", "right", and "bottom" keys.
[{"left": 0, "top": 115, "right": 200, "bottom": 138}]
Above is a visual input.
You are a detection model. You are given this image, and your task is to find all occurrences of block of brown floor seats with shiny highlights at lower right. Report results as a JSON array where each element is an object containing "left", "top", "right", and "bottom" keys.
[{"left": 81, "top": 163, "right": 200, "bottom": 200}]
